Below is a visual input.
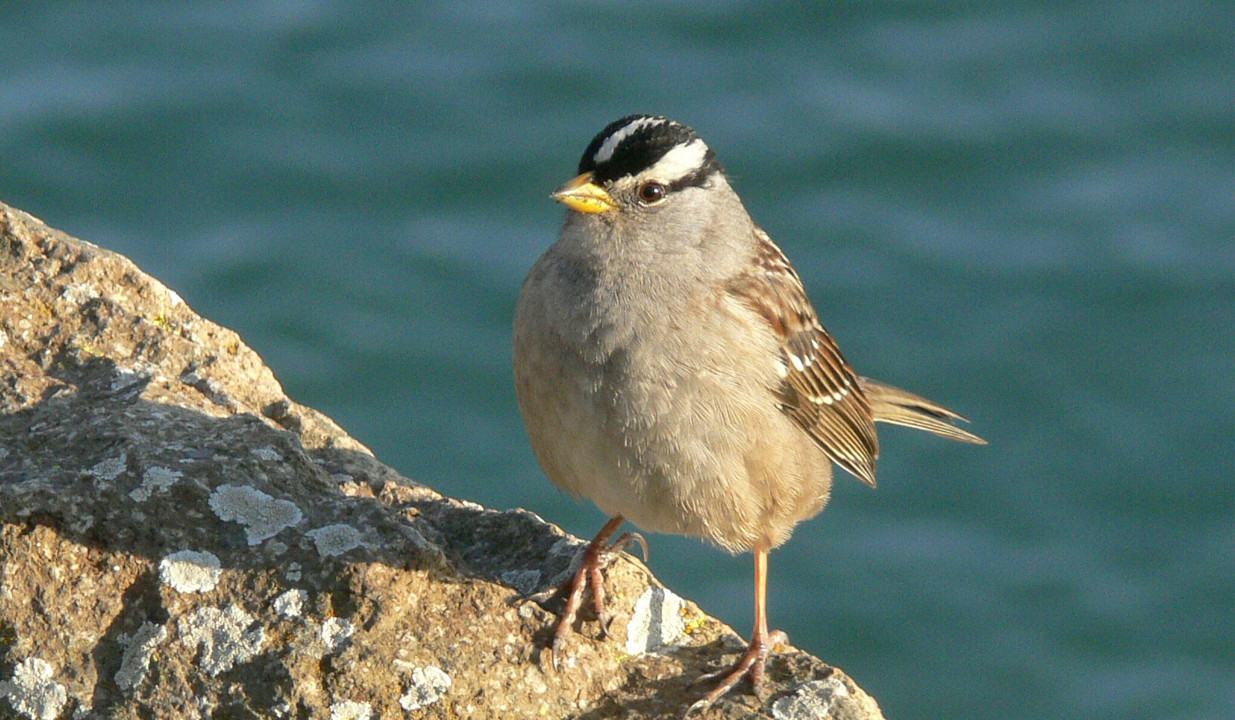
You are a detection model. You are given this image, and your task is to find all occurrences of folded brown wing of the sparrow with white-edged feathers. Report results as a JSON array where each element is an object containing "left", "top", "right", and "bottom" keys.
[{"left": 727, "top": 228, "right": 879, "bottom": 487}]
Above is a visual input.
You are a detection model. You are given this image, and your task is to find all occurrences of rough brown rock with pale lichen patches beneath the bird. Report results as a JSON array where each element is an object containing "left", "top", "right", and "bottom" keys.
[{"left": 0, "top": 198, "right": 881, "bottom": 719}]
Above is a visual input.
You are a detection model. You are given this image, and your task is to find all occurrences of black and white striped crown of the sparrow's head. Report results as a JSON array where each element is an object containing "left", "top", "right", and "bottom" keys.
[{"left": 579, "top": 115, "right": 724, "bottom": 188}]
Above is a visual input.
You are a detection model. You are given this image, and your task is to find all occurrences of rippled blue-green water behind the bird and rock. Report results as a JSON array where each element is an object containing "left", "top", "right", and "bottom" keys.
[{"left": 0, "top": 0, "right": 1235, "bottom": 720}]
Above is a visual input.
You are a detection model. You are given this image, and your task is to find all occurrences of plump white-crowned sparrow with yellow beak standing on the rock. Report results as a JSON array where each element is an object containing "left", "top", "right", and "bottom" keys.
[{"left": 514, "top": 115, "right": 983, "bottom": 705}]
